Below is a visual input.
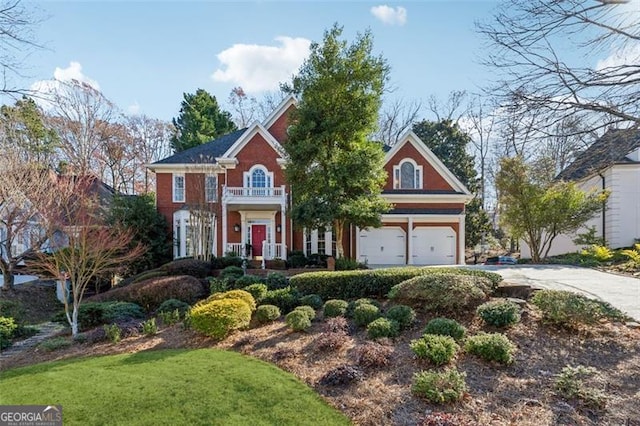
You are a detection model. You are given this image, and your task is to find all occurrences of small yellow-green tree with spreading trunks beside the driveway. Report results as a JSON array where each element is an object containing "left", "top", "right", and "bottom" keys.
[{"left": 496, "top": 157, "right": 608, "bottom": 262}]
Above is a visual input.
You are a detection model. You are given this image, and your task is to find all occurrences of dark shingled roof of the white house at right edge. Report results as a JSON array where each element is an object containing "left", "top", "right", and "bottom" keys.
[{"left": 556, "top": 129, "right": 640, "bottom": 180}]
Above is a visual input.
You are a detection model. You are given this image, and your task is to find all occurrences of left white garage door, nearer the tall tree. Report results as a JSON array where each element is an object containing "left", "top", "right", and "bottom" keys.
[{"left": 358, "top": 227, "right": 407, "bottom": 265}]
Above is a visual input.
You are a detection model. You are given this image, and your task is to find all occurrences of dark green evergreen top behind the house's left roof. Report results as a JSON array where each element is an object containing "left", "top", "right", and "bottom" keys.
[{"left": 171, "top": 89, "right": 236, "bottom": 152}]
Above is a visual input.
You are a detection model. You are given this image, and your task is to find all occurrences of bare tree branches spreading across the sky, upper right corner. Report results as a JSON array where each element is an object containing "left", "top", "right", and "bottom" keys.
[{"left": 477, "top": 0, "right": 640, "bottom": 133}]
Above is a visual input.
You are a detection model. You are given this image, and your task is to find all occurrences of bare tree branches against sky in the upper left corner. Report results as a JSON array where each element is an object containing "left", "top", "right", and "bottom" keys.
[{"left": 0, "top": 0, "right": 41, "bottom": 95}]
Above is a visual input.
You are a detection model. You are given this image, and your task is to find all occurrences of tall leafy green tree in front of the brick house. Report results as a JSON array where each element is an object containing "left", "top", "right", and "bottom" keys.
[{"left": 283, "top": 25, "right": 389, "bottom": 257}]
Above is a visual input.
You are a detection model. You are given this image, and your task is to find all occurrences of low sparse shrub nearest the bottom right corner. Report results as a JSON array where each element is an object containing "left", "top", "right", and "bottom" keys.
[{"left": 554, "top": 365, "right": 607, "bottom": 409}]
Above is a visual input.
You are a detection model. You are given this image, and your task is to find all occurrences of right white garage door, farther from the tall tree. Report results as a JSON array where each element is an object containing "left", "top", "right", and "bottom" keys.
[{"left": 412, "top": 226, "right": 456, "bottom": 265}]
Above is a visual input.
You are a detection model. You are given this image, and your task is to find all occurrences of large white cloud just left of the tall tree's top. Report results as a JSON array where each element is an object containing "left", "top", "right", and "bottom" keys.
[{"left": 211, "top": 36, "right": 311, "bottom": 93}]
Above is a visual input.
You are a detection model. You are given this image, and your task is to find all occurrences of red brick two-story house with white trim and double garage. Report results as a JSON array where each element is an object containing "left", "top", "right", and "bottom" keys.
[{"left": 148, "top": 97, "right": 472, "bottom": 265}]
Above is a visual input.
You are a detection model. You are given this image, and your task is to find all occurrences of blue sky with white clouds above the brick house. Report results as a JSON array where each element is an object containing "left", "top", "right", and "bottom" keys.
[{"left": 17, "top": 0, "right": 496, "bottom": 120}]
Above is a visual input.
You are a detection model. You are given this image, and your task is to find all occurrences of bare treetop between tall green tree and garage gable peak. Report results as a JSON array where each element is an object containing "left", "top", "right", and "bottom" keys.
[{"left": 375, "top": 99, "right": 422, "bottom": 146}]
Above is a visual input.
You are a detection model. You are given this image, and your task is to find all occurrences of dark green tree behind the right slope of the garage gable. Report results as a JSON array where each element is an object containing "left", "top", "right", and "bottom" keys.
[{"left": 413, "top": 119, "right": 491, "bottom": 246}]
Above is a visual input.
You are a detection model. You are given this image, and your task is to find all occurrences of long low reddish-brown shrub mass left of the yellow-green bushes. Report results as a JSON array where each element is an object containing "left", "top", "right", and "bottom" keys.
[{"left": 91, "top": 275, "right": 205, "bottom": 312}]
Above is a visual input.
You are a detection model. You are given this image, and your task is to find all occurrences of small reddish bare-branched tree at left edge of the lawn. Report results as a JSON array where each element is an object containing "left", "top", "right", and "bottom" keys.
[{"left": 29, "top": 178, "right": 144, "bottom": 337}]
